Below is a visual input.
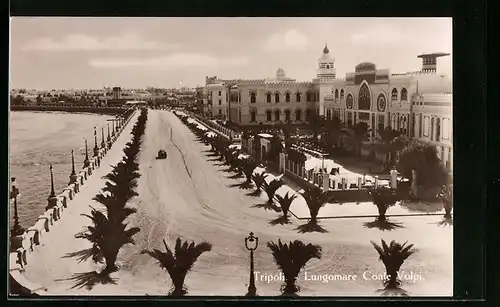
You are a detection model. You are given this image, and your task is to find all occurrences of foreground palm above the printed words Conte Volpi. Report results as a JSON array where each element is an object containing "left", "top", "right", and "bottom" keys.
[{"left": 370, "top": 239, "right": 416, "bottom": 289}]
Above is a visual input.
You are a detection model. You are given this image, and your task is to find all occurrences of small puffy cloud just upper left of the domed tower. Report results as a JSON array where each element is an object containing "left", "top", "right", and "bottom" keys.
[{"left": 349, "top": 24, "right": 405, "bottom": 45}]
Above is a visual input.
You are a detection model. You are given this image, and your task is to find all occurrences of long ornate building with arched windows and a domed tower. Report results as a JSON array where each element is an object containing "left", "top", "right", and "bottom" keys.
[{"left": 204, "top": 46, "right": 452, "bottom": 166}]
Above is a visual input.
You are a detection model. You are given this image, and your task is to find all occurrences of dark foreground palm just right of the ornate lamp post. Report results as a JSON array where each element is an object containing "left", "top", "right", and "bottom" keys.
[{"left": 267, "top": 239, "right": 322, "bottom": 295}]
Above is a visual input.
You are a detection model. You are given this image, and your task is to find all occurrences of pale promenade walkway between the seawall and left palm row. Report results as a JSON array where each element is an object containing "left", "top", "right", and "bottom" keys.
[{"left": 23, "top": 112, "right": 139, "bottom": 295}]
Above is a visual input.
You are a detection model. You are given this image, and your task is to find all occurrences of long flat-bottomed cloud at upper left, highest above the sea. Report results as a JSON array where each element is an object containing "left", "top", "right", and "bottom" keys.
[{"left": 23, "top": 33, "right": 177, "bottom": 51}]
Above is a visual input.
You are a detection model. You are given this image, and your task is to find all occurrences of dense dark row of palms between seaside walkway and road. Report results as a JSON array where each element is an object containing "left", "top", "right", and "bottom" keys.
[{"left": 75, "top": 108, "right": 148, "bottom": 275}]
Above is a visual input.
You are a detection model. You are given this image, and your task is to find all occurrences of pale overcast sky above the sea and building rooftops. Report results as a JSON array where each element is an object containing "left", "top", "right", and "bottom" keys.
[{"left": 10, "top": 17, "right": 452, "bottom": 89}]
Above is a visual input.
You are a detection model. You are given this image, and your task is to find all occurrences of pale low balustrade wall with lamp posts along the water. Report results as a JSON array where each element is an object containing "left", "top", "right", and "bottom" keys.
[{"left": 9, "top": 109, "right": 134, "bottom": 296}]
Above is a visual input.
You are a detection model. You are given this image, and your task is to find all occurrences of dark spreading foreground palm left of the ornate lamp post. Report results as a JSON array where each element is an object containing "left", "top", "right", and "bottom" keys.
[{"left": 141, "top": 238, "right": 212, "bottom": 296}]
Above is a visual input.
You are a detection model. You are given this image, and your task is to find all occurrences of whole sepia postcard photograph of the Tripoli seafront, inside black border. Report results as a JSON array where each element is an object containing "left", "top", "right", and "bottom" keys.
[{"left": 6, "top": 17, "right": 454, "bottom": 298}]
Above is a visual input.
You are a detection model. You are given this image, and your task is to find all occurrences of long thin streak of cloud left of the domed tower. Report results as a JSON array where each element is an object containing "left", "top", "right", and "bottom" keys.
[{"left": 89, "top": 53, "right": 249, "bottom": 70}]
